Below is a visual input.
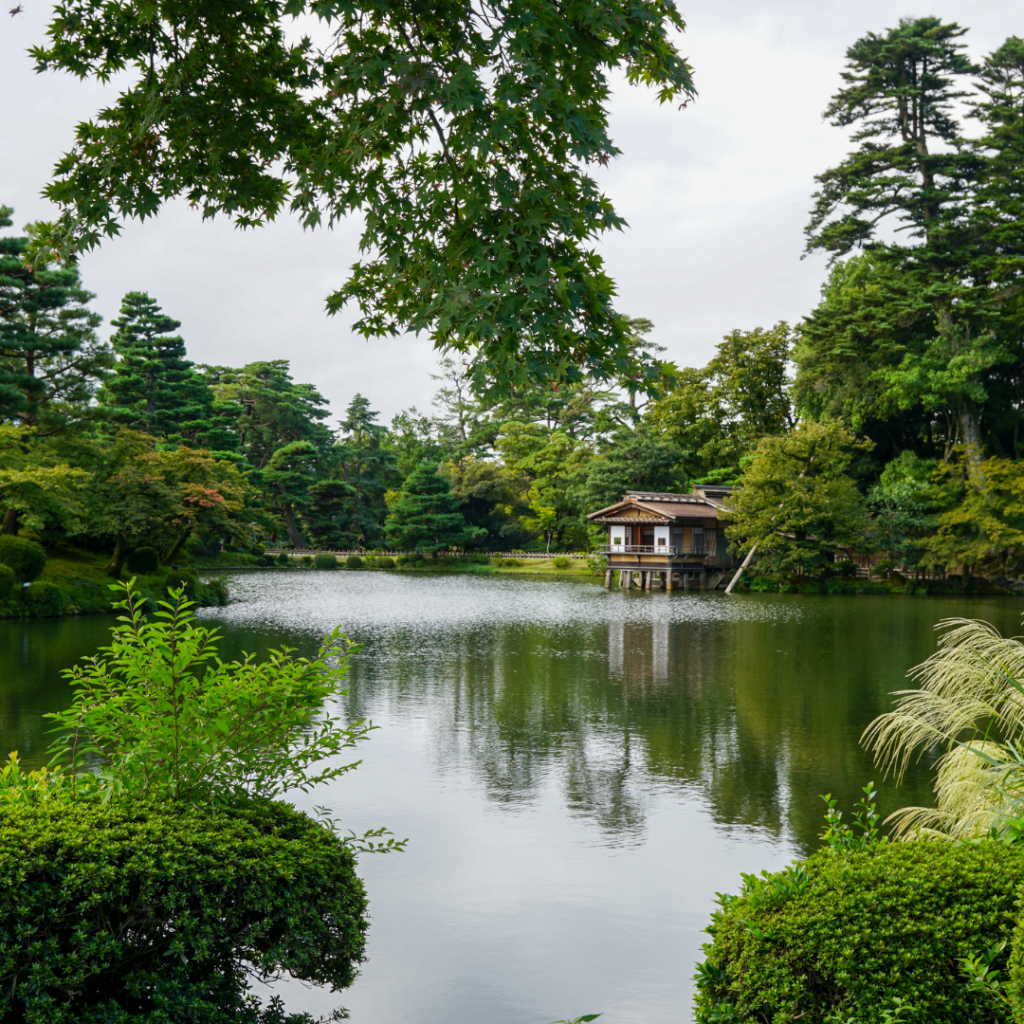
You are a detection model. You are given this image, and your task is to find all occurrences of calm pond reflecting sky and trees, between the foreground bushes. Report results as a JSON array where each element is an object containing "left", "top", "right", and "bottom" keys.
[{"left": 0, "top": 571, "right": 1024, "bottom": 1024}]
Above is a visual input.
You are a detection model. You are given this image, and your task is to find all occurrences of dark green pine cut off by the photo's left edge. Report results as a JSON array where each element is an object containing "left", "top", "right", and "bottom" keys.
[{"left": 0, "top": 207, "right": 111, "bottom": 433}]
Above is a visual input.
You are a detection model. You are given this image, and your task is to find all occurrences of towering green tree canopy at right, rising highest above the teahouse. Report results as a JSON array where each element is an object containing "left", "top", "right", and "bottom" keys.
[{"left": 798, "top": 17, "right": 1024, "bottom": 460}]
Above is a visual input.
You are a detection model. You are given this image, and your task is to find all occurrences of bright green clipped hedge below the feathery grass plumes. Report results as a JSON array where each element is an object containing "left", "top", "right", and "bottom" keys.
[{"left": 695, "top": 841, "right": 1024, "bottom": 1024}]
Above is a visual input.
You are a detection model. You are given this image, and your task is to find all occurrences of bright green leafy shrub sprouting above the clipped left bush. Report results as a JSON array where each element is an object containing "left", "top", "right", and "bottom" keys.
[{"left": 48, "top": 582, "right": 389, "bottom": 823}]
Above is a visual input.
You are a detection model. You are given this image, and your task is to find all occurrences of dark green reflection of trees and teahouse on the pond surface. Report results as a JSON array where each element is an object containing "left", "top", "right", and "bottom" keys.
[{"left": 350, "top": 602, "right": 932, "bottom": 849}]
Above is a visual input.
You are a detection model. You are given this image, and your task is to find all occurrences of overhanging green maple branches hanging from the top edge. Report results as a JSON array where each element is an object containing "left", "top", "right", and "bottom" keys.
[{"left": 28, "top": 0, "right": 693, "bottom": 385}]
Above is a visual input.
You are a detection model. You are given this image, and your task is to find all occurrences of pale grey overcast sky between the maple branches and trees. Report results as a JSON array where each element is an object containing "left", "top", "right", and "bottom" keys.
[{"left": 0, "top": 0, "right": 1024, "bottom": 422}]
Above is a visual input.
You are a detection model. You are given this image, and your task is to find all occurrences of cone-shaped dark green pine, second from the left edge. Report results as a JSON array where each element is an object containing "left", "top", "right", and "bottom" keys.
[{"left": 98, "top": 292, "right": 214, "bottom": 443}]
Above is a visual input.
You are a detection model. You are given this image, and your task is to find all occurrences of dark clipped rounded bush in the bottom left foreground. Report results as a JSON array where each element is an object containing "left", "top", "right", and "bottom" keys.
[{"left": 0, "top": 801, "right": 367, "bottom": 1024}]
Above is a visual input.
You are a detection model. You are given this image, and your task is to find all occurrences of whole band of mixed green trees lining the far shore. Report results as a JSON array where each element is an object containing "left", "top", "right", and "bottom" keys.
[{"left": 0, "top": 18, "right": 1024, "bottom": 583}]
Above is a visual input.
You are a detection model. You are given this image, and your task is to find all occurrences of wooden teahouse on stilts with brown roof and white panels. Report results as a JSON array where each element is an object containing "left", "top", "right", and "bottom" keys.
[{"left": 587, "top": 486, "right": 732, "bottom": 590}]
